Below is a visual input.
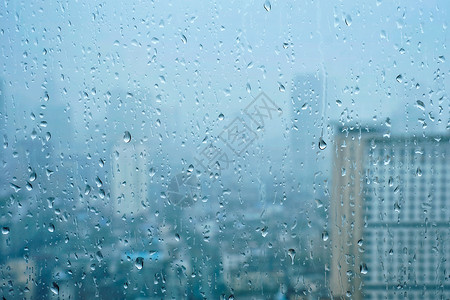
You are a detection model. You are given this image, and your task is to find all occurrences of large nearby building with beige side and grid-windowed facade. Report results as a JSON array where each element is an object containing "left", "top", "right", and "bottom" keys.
[{"left": 330, "top": 128, "right": 450, "bottom": 299}]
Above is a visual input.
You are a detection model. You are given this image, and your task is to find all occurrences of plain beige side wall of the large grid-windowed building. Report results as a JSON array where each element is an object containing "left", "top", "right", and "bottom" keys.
[{"left": 329, "top": 129, "right": 368, "bottom": 299}]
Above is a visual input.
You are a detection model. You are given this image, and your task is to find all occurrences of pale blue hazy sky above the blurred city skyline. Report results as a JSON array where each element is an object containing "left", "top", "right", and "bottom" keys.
[{"left": 0, "top": 0, "right": 450, "bottom": 155}]
